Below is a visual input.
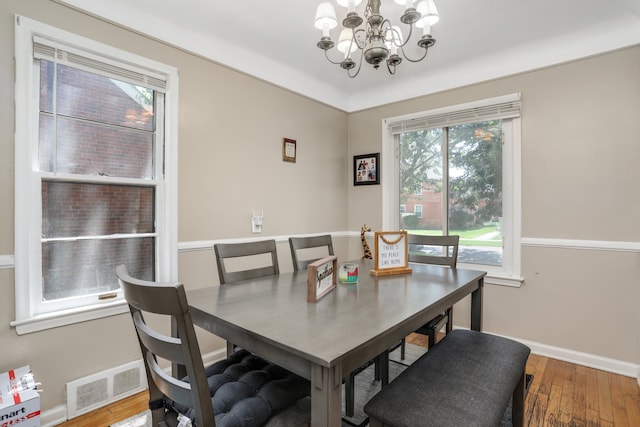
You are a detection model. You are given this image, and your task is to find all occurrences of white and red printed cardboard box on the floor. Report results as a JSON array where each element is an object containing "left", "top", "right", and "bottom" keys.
[{"left": 0, "top": 365, "right": 40, "bottom": 427}]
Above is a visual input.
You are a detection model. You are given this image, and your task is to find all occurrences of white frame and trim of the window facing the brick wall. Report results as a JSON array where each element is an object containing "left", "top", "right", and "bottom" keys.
[{"left": 13, "top": 15, "right": 179, "bottom": 324}]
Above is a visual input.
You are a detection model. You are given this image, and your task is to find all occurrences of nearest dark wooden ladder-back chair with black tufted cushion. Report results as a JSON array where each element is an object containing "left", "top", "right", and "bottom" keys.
[{"left": 116, "top": 265, "right": 311, "bottom": 427}]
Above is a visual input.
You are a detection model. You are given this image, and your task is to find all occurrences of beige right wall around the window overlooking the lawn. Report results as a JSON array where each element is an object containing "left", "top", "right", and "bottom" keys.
[{"left": 349, "top": 46, "right": 640, "bottom": 364}]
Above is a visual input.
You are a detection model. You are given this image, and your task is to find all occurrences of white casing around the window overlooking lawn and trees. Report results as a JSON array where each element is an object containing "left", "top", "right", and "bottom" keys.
[{"left": 382, "top": 94, "right": 522, "bottom": 286}]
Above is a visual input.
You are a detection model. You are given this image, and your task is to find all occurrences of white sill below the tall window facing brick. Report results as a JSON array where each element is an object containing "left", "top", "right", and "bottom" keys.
[{"left": 10, "top": 300, "right": 129, "bottom": 335}]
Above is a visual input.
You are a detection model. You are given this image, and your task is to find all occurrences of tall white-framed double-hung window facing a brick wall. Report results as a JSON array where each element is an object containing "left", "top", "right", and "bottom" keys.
[{"left": 13, "top": 16, "right": 177, "bottom": 333}]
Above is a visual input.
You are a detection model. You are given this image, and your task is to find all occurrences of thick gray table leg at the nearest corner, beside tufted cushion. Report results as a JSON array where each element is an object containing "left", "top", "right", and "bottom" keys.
[{"left": 311, "top": 365, "right": 342, "bottom": 427}]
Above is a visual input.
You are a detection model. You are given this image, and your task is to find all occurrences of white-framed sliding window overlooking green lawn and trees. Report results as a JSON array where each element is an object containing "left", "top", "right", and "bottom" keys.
[{"left": 383, "top": 94, "right": 521, "bottom": 286}]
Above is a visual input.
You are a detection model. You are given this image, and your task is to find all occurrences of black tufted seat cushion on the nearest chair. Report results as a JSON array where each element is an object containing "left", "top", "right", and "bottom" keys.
[{"left": 171, "top": 350, "right": 311, "bottom": 427}]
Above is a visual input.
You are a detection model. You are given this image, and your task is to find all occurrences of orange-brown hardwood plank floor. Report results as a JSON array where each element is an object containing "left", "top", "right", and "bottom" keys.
[{"left": 55, "top": 334, "right": 640, "bottom": 427}]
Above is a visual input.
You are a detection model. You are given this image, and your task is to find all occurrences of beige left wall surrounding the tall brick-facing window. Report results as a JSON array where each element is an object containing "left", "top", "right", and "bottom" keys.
[{"left": 0, "top": 0, "right": 348, "bottom": 411}]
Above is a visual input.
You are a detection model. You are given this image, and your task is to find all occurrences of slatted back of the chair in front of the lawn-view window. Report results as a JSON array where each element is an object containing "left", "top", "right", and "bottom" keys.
[{"left": 407, "top": 234, "right": 460, "bottom": 268}]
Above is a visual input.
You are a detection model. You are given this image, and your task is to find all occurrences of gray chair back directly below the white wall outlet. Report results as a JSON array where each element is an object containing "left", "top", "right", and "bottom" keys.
[{"left": 213, "top": 240, "right": 280, "bottom": 285}]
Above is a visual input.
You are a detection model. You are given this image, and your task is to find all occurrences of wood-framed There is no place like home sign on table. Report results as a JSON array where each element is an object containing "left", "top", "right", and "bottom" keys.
[{"left": 370, "top": 230, "right": 411, "bottom": 276}]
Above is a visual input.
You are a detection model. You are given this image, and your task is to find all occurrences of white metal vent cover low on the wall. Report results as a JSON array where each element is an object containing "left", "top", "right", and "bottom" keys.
[{"left": 67, "top": 360, "right": 147, "bottom": 419}]
